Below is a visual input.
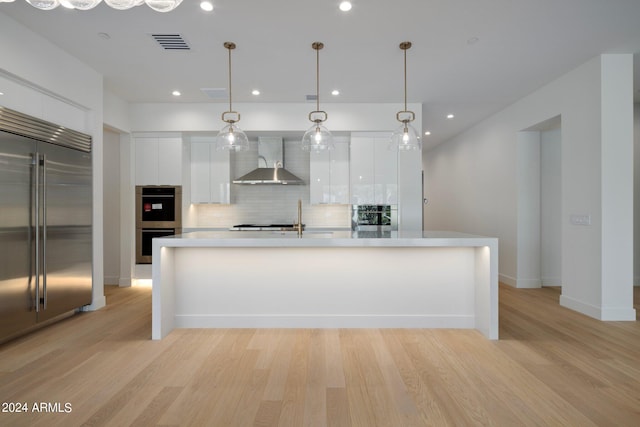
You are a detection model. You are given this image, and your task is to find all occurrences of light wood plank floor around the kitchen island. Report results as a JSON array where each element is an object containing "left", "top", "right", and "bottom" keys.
[{"left": 0, "top": 286, "right": 640, "bottom": 427}]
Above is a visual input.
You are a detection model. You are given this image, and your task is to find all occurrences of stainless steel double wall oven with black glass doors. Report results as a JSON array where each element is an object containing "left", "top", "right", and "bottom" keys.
[{"left": 136, "top": 185, "right": 182, "bottom": 264}]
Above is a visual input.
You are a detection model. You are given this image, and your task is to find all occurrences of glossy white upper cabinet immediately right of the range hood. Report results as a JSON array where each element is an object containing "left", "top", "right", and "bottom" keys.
[{"left": 309, "top": 137, "right": 349, "bottom": 205}]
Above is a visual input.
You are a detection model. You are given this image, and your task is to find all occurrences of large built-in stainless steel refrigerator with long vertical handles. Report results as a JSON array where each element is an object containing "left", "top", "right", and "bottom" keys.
[{"left": 0, "top": 107, "right": 92, "bottom": 341}]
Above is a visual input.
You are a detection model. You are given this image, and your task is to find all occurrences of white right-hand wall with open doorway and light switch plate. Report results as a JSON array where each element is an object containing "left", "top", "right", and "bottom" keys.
[{"left": 423, "top": 54, "right": 635, "bottom": 320}]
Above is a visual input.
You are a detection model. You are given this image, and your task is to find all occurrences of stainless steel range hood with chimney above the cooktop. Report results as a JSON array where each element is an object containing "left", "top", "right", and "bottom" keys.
[{"left": 233, "top": 137, "right": 304, "bottom": 185}]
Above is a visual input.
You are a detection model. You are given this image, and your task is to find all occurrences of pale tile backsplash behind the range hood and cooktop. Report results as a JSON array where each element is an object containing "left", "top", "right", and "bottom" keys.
[{"left": 189, "top": 138, "right": 351, "bottom": 228}]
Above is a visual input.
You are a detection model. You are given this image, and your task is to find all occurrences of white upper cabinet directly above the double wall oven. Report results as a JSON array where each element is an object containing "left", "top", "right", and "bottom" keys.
[{"left": 134, "top": 137, "right": 182, "bottom": 185}]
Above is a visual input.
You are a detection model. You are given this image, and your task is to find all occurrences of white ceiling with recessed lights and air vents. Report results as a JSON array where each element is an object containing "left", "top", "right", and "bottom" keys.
[{"left": 0, "top": 0, "right": 640, "bottom": 147}]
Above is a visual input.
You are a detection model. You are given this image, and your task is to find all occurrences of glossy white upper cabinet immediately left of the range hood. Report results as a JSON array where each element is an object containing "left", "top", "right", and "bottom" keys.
[{"left": 191, "top": 137, "right": 231, "bottom": 204}]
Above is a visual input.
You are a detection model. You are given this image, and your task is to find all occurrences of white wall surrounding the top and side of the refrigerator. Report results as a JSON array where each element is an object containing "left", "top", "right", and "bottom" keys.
[{"left": 0, "top": 13, "right": 105, "bottom": 309}]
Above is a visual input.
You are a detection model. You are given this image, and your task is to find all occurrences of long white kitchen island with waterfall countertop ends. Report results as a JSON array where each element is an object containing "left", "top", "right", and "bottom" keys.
[{"left": 152, "top": 231, "right": 498, "bottom": 339}]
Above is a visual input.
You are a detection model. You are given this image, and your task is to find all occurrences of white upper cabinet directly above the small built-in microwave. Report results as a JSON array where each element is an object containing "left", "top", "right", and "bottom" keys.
[{"left": 350, "top": 132, "right": 398, "bottom": 205}]
